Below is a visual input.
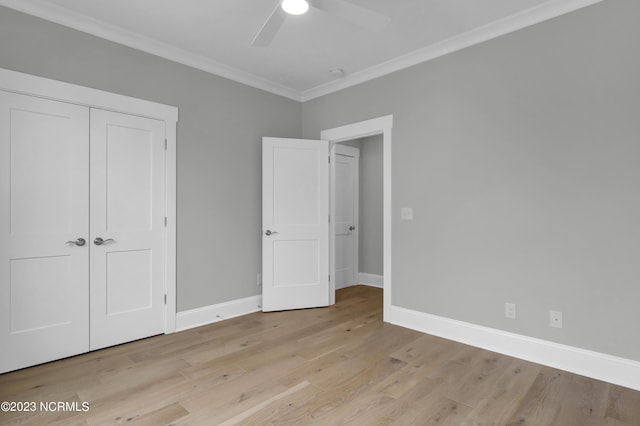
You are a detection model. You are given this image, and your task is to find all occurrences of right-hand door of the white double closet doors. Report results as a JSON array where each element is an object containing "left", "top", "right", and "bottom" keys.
[{"left": 89, "top": 109, "right": 165, "bottom": 350}]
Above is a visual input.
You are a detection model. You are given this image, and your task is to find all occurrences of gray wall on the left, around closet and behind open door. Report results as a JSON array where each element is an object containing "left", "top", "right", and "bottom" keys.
[{"left": 0, "top": 7, "right": 301, "bottom": 311}]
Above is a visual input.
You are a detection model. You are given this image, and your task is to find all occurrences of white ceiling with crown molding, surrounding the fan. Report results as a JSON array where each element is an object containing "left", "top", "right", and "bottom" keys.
[{"left": 0, "top": 0, "right": 601, "bottom": 101}]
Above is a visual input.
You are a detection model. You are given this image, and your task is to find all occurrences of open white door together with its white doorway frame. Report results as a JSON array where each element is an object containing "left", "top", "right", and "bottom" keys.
[{"left": 262, "top": 116, "right": 393, "bottom": 318}]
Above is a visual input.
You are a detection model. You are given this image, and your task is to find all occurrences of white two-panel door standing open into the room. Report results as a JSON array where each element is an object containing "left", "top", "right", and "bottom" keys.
[{"left": 262, "top": 138, "right": 330, "bottom": 311}]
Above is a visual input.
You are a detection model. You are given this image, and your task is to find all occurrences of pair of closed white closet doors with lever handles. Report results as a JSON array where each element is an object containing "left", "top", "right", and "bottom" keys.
[{"left": 0, "top": 91, "right": 165, "bottom": 373}]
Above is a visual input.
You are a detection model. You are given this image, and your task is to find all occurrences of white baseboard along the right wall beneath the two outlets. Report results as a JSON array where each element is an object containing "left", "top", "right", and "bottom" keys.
[{"left": 388, "top": 306, "right": 640, "bottom": 390}]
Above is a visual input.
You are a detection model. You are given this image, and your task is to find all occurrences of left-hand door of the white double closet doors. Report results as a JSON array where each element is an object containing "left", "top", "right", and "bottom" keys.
[{"left": 0, "top": 91, "right": 89, "bottom": 373}]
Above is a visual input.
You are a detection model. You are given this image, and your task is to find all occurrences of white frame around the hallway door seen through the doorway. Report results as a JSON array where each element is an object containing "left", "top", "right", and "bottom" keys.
[{"left": 329, "top": 143, "right": 360, "bottom": 287}]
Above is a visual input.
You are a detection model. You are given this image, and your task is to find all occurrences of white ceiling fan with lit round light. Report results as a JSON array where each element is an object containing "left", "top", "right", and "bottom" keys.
[{"left": 251, "top": 0, "right": 390, "bottom": 46}]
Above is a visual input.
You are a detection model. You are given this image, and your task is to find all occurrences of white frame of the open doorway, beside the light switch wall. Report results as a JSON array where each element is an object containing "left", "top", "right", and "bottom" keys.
[{"left": 320, "top": 115, "right": 393, "bottom": 321}]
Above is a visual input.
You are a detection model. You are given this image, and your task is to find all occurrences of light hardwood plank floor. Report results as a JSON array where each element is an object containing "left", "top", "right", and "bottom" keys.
[{"left": 0, "top": 286, "right": 640, "bottom": 426}]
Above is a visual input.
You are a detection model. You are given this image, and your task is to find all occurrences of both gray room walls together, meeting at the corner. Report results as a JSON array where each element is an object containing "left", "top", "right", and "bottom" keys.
[{"left": 0, "top": 0, "right": 640, "bottom": 360}]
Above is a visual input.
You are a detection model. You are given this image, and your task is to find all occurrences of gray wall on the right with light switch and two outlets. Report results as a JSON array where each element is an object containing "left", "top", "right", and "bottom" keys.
[{"left": 302, "top": 0, "right": 640, "bottom": 360}]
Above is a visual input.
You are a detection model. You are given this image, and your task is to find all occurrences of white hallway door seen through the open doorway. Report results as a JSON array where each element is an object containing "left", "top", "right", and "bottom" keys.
[{"left": 331, "top": 144, "right": 360, "bottom": 289}]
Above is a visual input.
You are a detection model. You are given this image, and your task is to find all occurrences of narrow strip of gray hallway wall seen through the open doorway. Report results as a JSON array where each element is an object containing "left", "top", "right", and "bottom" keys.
[{"left": 358, "top": 135, "right": 384, "bottom": 275}]
